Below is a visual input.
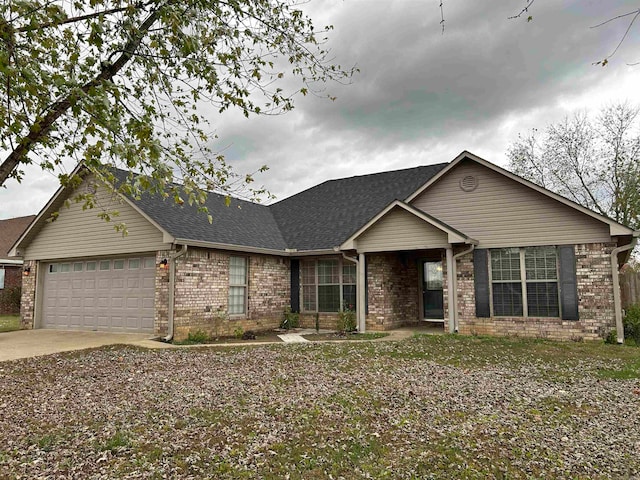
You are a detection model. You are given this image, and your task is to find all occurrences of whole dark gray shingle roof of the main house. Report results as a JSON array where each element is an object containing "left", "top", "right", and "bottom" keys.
[{"left": 117, "top": 163, "right": 447, "bottom": 250}]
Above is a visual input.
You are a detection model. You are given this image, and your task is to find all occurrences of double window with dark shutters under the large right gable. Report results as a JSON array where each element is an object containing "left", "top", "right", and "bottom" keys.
[{"left": 490, "top": 247, "right": 560, "bottom": 317}]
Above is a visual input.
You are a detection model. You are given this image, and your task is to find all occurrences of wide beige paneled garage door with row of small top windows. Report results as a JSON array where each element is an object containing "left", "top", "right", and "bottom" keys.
[{"left": 42, "top": 256, "right": 155, "bottom": 333}]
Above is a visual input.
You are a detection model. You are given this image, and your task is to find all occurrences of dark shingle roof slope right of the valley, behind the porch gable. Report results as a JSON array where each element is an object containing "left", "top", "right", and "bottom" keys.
[{"left": 270, "top": 163, "right": 448, "bottom": 250}]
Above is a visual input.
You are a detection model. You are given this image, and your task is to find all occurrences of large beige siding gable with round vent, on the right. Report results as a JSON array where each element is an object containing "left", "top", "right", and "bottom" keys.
[{"left": 411, "top": 160, "right": 611, "bottom": 247}]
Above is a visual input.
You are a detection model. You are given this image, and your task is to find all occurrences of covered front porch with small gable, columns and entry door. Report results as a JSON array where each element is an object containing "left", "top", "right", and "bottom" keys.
[{"left": 340, "top": 200, "right": 477, "bottom": 332}]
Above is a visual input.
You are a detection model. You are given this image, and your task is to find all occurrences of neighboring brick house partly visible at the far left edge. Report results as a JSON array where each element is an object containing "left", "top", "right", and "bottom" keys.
[{"left": 0, "top": 215, "right": 35, "bottom": 315}]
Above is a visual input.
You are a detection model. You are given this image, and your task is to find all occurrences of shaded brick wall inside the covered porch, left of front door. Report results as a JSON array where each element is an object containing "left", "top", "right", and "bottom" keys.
[{"left": 366, "top": 253, "right": 420, "bottom": 330}]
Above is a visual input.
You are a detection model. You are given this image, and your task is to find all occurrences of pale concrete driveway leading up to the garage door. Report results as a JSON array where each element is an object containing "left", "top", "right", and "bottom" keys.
[{"left": 0, "top": 329, "right": 172, "bottom": 362}]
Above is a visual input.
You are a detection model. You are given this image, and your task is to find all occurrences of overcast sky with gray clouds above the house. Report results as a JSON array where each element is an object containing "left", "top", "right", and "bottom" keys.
[{"left": 0, "top": 0, "right": 640, "bottom": 219}]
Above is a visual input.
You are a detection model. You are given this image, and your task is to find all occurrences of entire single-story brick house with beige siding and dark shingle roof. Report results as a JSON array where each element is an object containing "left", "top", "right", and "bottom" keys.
[{"left": 12, "top": 152, "right": 640, "bottom": 339}]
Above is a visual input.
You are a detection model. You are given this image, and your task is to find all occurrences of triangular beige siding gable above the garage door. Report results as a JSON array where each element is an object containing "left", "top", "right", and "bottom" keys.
[{"left": 24, "top": 175, "right": 169, "bottom": 260}]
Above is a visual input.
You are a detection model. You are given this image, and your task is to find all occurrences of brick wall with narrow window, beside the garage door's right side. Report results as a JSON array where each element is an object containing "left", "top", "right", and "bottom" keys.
[{"left": 170, "top": 249, "right": 290, "bottom": 340}]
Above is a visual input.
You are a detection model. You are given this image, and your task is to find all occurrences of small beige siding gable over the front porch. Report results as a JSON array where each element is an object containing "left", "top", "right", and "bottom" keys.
[{"left": 356, "top": 207, "right": 449, "bottom": 252}]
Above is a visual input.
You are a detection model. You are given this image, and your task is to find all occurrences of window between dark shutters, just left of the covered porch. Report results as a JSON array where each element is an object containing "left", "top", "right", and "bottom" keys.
[{"left": 301, "top": 259, "right": 356, "bottom": 313}]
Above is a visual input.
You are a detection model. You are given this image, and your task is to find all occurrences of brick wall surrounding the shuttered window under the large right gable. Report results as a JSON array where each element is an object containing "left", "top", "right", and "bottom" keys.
[{"left": 457, "top": 243, "right": 615, "bottom": 340}]
